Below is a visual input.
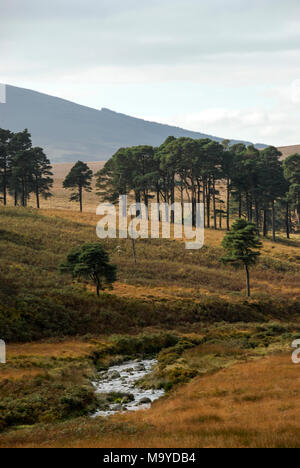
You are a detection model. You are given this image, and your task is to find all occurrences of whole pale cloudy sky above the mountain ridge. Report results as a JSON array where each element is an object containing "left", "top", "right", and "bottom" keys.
[{"left": 0, "top": 0, "right": 300, "bottom": 146}]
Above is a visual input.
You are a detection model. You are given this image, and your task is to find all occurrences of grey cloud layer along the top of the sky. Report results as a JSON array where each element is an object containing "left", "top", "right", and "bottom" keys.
[{"left": 0, "top": 0, "right": 300, "bottom": 70}]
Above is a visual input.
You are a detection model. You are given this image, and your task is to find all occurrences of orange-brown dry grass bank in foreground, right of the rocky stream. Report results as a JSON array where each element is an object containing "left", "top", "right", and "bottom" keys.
[{"left": 0, "top": 355, "right": 300, "bottom": 448}]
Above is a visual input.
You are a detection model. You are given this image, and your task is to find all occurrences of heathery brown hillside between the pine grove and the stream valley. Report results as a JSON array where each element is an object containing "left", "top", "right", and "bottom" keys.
[{"left": 0, "top": 208, "right": 300, "bottom": 341}]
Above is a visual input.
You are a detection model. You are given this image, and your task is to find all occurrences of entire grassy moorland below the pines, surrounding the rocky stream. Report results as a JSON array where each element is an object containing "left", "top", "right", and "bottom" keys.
[{"left": 0, "top": 207, "right": 300, "bottom": 447}]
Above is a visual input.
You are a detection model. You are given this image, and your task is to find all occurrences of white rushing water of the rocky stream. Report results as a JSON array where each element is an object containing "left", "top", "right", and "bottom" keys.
[{"left": 94, "top": 359, "right": 165, "bottom": 417}]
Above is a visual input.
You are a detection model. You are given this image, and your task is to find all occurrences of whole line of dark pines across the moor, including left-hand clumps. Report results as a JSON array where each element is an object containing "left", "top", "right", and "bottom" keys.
[{"left": 0, "top": 129, "right": 300, "bottom": 240}]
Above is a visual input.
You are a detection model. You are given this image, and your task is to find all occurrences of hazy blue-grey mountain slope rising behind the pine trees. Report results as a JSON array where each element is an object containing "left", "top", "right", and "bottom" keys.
[{"left": 0, "top": 85, "right": 264, "bottom": 163}]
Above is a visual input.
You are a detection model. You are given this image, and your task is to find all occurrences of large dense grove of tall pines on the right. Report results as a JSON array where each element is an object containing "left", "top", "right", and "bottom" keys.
[{"left": 97, "top": 137, "right": 300, "bottom": 240}]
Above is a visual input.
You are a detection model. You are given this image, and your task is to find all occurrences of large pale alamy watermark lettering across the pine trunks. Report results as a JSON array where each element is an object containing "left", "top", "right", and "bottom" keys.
[{"left": 96, "top": 195, "right": 204, "bottom": 250}]
